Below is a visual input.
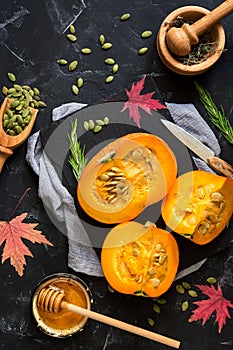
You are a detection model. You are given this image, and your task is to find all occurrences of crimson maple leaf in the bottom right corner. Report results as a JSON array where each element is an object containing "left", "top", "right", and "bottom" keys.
[{"left": 189, "top": 285, "right": 233, "bottom": 333}]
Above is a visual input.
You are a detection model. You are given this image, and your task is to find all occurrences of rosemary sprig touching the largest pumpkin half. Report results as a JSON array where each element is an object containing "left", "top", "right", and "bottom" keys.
[{"left": 68, "top": 119, "right": 87, "bottom": 181}]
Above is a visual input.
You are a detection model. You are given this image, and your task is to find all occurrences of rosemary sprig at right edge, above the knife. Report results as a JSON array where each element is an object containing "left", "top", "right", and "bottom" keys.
[{"left": 194, "top": 81, "right": 233, "bottom": 143}]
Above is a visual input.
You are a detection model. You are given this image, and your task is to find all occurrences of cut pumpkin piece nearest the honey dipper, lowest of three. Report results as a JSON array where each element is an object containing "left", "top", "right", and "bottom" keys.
[{"left": 101, "top": 221, "right": 179, "bottom": 298}]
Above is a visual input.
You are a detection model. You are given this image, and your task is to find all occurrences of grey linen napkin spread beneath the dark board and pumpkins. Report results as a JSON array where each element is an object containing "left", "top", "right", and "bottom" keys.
[{"left": 26, "top": 103, "right": 220, "bottom": 278}]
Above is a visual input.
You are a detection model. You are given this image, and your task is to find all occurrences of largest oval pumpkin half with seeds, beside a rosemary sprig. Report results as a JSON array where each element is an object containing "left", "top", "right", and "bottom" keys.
[{"left": 77, "top": 133, "right": 177, "bottom": 224}]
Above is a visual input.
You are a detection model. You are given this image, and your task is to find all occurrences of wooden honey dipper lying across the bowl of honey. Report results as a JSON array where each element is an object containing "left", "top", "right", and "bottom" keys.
[{"left": 37, "top": 288, "right": 180, "bottom": 349}]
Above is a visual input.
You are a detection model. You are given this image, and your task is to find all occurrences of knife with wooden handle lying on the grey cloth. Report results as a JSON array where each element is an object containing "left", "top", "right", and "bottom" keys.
[{"left": 161, "top": 119, "right": 233, "bottom": 179}]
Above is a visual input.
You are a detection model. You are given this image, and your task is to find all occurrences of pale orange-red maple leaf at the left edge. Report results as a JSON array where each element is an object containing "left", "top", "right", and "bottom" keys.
[{"left": 0, "top": 213, "right": 52, "bottom": 276}]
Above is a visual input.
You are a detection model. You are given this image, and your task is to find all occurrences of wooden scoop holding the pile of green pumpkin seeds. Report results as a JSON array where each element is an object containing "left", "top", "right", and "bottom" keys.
[{"left": 0, "top": 98, "right": 38, "bottom": 173}]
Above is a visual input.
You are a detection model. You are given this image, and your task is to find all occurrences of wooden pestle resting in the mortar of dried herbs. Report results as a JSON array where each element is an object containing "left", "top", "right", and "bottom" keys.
[{"left": 166, "top": 0, "right": 233, "bottom": 56}]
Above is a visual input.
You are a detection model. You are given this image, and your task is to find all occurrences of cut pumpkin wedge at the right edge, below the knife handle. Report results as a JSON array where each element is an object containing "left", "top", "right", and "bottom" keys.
[{"left": 162, "top": 170, "right": 233, "bottom": 245}]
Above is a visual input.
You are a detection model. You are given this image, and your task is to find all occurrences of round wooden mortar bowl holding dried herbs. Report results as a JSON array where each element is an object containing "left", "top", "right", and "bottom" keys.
[{"left": 156, "top": 6, "right": 225, "bottom": 76}]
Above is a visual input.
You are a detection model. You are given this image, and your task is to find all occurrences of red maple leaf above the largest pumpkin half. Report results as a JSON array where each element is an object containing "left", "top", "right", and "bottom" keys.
[{"left": 121, "top": 76, "right": 167, "bottom": 128}]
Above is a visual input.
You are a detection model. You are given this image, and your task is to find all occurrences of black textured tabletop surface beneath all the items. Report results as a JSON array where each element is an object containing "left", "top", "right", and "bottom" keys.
[{"left": 0, "top": 0, "right": 233, "bottom": 350}]
